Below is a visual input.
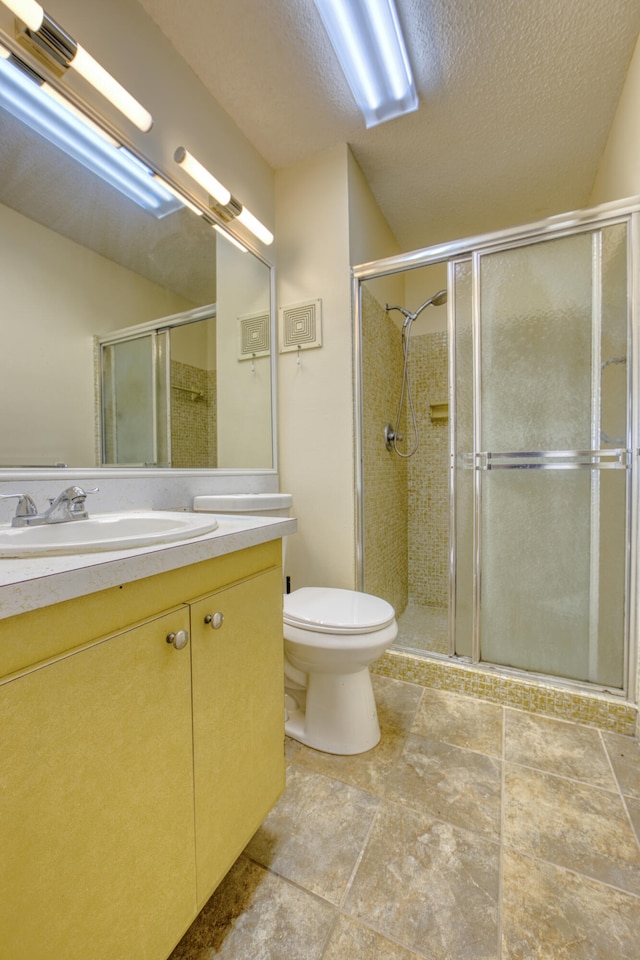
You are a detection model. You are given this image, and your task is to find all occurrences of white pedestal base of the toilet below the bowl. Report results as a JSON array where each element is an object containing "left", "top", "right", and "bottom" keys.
[{"left": 285, "top": 667, "right": 380, "bottom": 756}]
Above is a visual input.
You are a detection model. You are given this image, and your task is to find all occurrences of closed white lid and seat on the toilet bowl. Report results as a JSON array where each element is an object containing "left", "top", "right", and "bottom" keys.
[{"left": 284, "top": 587, "right": 395, "bottom": 633}]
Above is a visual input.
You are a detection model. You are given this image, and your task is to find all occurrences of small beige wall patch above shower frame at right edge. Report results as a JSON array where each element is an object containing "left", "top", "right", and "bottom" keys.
[{"left": 590, "top": 33, "right": 640, "bottom": 205}]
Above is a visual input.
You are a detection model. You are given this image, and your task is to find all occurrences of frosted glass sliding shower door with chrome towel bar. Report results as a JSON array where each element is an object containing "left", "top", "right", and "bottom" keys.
[{"left": 467, "top": 223, "right": 630, "bottom": 689}]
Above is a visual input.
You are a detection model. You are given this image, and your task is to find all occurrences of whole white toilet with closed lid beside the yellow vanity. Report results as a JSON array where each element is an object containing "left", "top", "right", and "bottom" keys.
[{"left": 194, "top": 494, "right": 398, "bottom": 755}]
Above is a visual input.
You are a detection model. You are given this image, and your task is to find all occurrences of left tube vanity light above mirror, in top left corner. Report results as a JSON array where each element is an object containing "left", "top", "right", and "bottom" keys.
[{"left": 2, "top": 0, "right": 153, "bottom": 133}]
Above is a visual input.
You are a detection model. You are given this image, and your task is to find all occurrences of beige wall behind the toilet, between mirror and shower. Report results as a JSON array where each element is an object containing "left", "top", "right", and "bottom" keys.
[{"left": 276, "top": 144, "right": 398, "bottom": 589}]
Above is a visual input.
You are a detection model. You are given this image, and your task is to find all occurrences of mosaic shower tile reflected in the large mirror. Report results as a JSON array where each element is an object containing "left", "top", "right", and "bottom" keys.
[{"left": 171, "top": 360, "right": 217, "bottom": 468}]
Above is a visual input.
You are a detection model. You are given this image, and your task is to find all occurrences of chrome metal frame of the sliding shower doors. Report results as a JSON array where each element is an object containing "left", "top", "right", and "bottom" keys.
[{"left": 352, "top": 198, "right": 640, "bottom": 699}]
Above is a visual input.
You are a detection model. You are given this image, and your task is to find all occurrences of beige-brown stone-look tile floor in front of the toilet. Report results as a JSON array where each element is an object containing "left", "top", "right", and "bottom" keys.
[{"left": 171, "top": 677, "right": 640, "bottom": 960}]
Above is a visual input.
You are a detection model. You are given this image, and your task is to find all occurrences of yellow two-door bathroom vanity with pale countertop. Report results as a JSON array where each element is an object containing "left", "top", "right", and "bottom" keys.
[{"left": 0, "top": 518, "right": 295, "bottom": 960}]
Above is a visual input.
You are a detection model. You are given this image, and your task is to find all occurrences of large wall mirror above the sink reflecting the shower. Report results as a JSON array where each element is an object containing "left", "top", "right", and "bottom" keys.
[{"left": 0, "top": 55, "right": 274, "bottom": 471}]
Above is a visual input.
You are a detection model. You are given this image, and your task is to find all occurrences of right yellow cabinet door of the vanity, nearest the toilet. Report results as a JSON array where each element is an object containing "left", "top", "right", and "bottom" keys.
[{"left": 191, "top": 568, "right": 285, "bottom": 907}]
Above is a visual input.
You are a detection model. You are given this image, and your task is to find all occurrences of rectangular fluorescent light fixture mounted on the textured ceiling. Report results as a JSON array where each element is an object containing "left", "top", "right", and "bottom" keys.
[{"left": 314, "top": 0, "right": 418, "bottom": 127}]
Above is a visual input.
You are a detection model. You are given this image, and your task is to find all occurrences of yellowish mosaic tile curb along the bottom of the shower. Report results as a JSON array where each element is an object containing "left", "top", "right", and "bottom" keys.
[{"left": 371, "top": 650, "right": 638, "bottom": 737}]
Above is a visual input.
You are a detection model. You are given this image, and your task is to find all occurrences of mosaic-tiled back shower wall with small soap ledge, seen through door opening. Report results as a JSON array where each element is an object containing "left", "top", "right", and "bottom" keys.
[{"left": 408, "top": 332, "right": 449, "bottom": 607}]
